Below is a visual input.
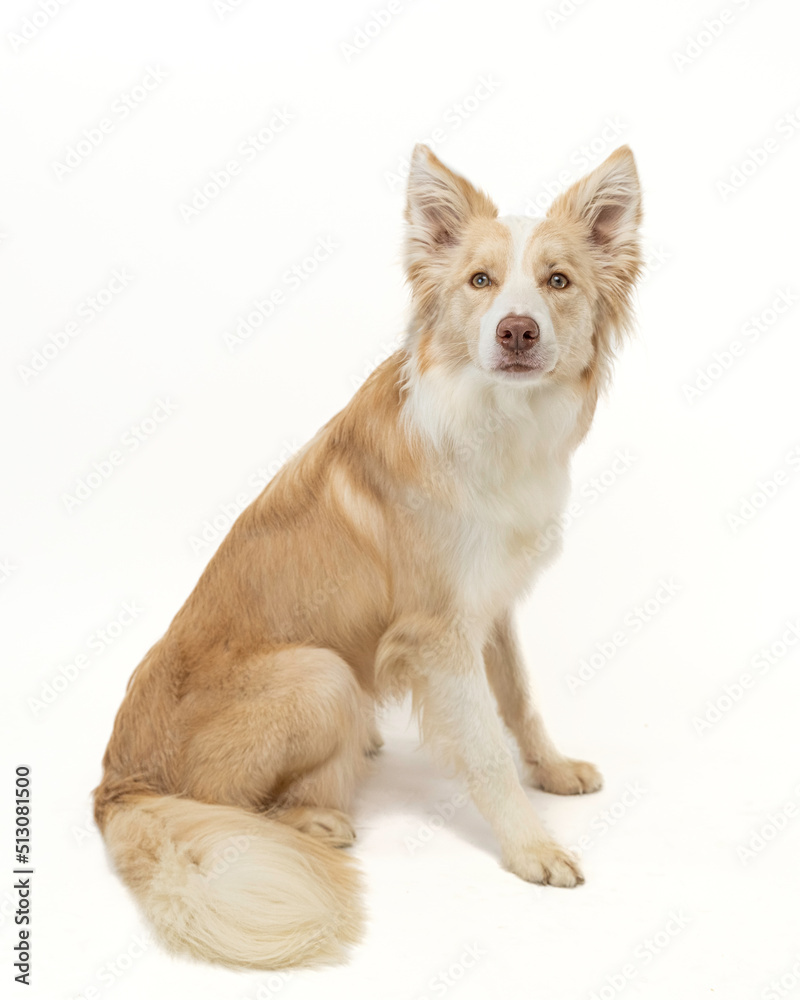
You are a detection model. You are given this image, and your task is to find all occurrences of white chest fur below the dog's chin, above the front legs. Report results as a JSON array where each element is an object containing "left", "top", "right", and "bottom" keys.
[{"left": 407, "top": 364, "right": 579, "bottom": 617}]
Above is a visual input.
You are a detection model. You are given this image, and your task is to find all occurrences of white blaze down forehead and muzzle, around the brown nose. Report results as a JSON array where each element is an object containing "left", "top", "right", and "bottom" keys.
[{"left": 478, "top": 215, "right": 558, "bottom": 381}]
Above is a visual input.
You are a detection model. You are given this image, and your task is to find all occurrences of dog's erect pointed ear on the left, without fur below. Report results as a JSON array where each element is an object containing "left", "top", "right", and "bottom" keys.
[{"left": 406, "top": 144, "right": 497, "bottom": 252}]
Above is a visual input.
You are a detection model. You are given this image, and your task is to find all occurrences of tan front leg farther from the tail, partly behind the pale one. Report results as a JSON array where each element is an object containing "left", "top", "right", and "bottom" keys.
[{"left": 484, "top": 614, "right": 603, "bottom": 795}]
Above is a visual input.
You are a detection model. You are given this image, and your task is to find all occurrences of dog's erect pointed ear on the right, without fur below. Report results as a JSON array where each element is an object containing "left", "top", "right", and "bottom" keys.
[{"left": 547, "top": 146, "right": 642, "bottom": 253}]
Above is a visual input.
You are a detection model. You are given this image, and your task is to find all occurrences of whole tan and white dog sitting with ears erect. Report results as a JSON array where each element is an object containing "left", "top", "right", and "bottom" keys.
[{"left": 95, "top": 145, "right": 642, "bottom": 969}]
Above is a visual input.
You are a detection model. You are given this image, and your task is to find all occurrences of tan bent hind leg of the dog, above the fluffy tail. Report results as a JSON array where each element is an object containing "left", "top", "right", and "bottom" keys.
[{"left": 183, "top": 647, "right": 372, "bottom": 828}]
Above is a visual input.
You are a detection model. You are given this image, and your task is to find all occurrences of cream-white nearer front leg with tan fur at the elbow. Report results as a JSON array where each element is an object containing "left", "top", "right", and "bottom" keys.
[{"left": 379, "top": 620, "right": 583, "bottom": 886}]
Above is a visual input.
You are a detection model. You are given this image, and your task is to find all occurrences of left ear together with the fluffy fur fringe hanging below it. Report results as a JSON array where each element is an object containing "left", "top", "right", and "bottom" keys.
[{"left": 405, "top": 144, "right": 497, "bottom": 317}]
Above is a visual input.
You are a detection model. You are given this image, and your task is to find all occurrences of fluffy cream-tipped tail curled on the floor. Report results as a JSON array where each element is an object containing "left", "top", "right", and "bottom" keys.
[{"left": 98, "top": 795, "right": 362, "bottom": 969}]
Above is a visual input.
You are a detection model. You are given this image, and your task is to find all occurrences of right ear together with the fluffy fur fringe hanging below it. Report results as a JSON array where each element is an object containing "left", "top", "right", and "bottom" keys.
[{"left": 547, "top": 146, "right": 642, "bottom": 350}]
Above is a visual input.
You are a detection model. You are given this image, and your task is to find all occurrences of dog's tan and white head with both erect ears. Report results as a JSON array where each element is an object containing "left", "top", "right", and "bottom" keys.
[{"left": 405, "top": 145, "right": 641, "bottom": 386}]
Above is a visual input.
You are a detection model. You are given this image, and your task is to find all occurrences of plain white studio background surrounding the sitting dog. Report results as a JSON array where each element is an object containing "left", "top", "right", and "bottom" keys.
[{"left": 0, "top": 0, "right": 800, "bottom": 1000}]
